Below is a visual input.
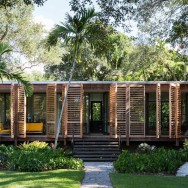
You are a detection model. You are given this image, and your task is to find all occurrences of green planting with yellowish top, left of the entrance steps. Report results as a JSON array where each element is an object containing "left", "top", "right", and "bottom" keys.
[{"left": 0, "top": 141, "right": 83, "bottom": 172}]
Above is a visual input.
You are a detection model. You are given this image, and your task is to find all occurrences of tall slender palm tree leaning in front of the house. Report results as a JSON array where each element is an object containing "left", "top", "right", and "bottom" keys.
[{"left": 47, "top": 8, "right": 97, "bottom": 149}]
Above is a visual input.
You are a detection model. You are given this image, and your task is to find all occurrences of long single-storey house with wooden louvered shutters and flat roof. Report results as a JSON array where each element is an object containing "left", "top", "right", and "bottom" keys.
[{"left": 0, "top": 81, "right": 188, "bottom": 145}]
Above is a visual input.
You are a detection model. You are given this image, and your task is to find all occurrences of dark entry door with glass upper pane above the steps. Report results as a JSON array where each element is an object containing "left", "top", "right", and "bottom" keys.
[{"left": 90, "top": 101, "right": 103, "bottom": 133}]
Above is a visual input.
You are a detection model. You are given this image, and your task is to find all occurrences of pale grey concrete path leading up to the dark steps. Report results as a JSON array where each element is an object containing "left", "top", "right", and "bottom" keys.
[{"left": 81, "top": 162, "right": 113, "bottom": 188}]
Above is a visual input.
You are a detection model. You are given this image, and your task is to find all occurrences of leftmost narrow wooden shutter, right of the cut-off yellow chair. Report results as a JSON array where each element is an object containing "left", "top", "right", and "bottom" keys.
[{"left": 10, "top": 84, "right": 17, "bottom": 138}]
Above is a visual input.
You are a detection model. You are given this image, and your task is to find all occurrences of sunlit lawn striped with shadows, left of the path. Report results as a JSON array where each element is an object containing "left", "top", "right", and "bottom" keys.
[{"left": 0, "top": 170, "right": 84, "bottom": 188}]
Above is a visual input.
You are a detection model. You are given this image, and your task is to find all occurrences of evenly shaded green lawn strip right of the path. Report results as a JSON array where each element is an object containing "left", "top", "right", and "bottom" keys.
[{"left": 110, "top": 173, "right": 188, "bottom": 188}]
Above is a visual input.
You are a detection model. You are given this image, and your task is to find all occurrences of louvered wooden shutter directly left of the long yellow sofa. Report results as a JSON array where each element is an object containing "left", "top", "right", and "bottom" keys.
[{"left": 17, "top": 86, "right": 26, "bottom": 138}]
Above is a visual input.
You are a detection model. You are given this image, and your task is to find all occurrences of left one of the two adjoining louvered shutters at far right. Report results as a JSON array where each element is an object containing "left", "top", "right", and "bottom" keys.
[{"left": 169, "top": 84, "right": 176, "bottom": 138}]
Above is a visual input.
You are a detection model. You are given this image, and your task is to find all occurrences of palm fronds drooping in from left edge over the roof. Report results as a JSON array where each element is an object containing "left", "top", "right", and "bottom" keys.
[{"left": 0, "top": 42, "right": 32, "bottom": 96}]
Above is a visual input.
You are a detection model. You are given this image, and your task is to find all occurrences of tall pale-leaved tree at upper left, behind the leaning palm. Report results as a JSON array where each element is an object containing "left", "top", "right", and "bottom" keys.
[{"left": 0, "top": 2, "right": 62, "bottom": 72}]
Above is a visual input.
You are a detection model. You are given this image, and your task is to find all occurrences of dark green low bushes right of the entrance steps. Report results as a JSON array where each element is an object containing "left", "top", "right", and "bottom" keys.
[{"left": 114, "top": 143, "right": 188, "bottom": 174}]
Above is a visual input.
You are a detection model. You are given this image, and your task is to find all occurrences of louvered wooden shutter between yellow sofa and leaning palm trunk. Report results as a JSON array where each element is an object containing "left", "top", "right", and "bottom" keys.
[{"left": 46, "top": 84, "right": 57, "bottom": 137}]
